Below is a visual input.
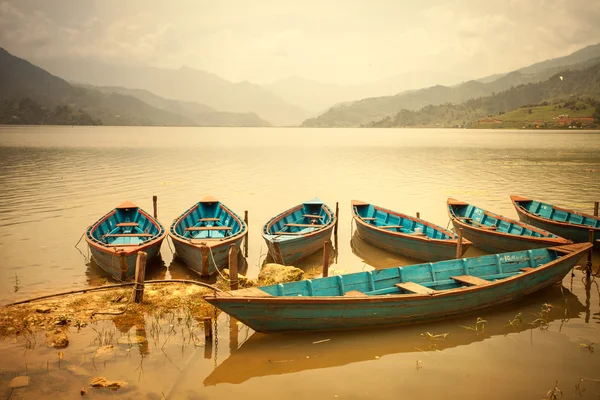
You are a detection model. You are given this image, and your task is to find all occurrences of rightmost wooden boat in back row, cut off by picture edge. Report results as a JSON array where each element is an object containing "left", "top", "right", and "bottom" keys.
[{"left": 510, "top": 196, "right": 600, "bottom": 250}]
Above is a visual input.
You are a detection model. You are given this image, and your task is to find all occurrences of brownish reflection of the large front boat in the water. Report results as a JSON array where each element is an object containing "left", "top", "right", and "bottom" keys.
[{"left": 204, "top": 285, "right": 585, "bottom": 386}]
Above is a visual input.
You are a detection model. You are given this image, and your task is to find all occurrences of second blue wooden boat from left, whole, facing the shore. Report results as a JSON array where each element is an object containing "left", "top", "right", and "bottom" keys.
[{"left": 169, "top": 196, "right": 248, "bottom": 277}]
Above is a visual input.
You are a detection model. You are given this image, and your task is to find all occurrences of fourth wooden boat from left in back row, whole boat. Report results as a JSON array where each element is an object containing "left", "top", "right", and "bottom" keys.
[{"left": 352, "top": 200, "right": 471, "bottom": 261}]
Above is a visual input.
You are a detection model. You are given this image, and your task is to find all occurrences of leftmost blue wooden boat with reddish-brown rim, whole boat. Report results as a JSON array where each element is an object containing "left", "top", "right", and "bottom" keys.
[{"left": 85, "top": 201, "right": 166, "bottom": 280}]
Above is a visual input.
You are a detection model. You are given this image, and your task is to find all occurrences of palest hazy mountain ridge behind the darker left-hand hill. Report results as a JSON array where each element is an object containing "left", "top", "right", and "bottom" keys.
[{"left": 38, "top": 59, "right": 311, "bottom": 125}]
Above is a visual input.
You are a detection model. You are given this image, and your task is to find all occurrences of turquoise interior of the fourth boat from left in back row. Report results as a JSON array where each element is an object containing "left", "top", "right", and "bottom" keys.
[{"left": 353, "top": 204, "right": 456, "bottom": 239}]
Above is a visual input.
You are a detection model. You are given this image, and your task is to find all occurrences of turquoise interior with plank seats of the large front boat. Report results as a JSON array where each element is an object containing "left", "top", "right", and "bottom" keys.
[{"left": 260, "top": 249, "right": 563, "bottom": 297}]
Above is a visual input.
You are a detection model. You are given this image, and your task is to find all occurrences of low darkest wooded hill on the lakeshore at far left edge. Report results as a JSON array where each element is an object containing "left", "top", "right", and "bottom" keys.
[{"left": 0, "top": 98, "right": 102, "bottom": 125}]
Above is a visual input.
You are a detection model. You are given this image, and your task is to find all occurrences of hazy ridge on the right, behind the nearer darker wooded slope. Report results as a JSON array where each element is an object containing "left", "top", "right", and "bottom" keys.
[{"left": 302, "top": 44, "right": 600, "bottom": 127}]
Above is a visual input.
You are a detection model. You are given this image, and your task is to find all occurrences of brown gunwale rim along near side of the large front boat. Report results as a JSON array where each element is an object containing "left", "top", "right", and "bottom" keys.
[{"left": 204, "top": 243, "right": 592, "bottom": 304}]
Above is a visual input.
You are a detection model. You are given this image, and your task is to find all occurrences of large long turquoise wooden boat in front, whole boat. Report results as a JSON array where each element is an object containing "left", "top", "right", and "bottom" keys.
[{"left": 204, "top": 243, "right": 592, "bottom": 333}]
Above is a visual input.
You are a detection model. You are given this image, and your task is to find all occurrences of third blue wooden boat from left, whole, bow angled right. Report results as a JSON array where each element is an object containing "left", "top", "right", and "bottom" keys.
[{"left": 263, "top": 198, "right": 336, "bottom": 265}]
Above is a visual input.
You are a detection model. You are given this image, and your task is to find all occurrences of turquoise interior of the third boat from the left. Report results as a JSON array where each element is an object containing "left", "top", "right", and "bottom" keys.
[{"left": 266, "top": 200, "right": 332, "bottom": 236}]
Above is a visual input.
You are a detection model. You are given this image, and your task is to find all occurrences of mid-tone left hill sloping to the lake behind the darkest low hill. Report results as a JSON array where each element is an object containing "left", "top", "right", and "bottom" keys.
[{"left": 0, "top": 48, "right": 268, "bottom": 126}]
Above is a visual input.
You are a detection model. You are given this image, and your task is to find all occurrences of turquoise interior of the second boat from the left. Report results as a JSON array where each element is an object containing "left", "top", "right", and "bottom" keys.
[{"left": 175, "top": 201, "right": 243, "bottom": 239}]
